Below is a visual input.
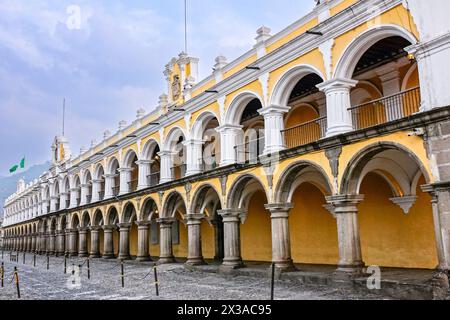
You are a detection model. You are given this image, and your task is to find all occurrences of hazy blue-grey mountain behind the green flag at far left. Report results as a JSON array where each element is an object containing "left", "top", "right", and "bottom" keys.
[{"left": 0, "top": 162, "right": 50, "bottom": 217}]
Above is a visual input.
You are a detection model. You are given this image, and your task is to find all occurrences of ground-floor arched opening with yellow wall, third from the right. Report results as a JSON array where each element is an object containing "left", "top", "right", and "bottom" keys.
[{"left": 228, "top": 176, "right": 272, "bottom": 262}]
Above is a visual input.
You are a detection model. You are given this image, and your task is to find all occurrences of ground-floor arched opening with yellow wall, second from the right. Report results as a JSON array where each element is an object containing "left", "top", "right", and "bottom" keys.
[{"left": 276, "top": 163, "right": 339, "bottom": 265}]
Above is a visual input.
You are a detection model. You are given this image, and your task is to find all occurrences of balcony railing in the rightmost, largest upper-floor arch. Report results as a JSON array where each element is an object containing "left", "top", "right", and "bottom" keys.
[{"left": 349, "top": 87, "right": 421, "bottom": 130}]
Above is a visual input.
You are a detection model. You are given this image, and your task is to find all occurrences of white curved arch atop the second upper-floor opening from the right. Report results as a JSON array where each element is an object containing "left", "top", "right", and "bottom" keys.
[{"left": 270, "top": 64, "right": 326, "bottom": 106}]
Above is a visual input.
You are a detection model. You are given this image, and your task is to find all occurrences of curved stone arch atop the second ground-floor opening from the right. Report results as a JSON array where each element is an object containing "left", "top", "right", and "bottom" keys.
[{"left": 275, "top": 161, "right": 334, "bottom": 203}]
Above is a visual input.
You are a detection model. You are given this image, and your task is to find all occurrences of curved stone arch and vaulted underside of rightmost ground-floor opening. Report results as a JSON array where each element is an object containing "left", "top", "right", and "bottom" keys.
[{"left": 340, "top": 142, "right": 431, "bottom": 196}]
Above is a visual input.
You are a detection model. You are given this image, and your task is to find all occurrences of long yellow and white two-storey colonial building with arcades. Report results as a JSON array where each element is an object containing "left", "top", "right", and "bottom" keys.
[{"left": 0, "top": 0, "right": 450, "bottom": 273}]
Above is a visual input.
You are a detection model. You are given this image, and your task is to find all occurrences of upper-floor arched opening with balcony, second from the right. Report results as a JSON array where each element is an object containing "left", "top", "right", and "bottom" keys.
[{"left": 282, "top": 72, "right": 327, "bottom": 148}]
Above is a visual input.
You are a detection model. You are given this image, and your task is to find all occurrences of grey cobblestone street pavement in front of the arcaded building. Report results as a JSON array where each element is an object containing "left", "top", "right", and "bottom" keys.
[{"left": 0, "top": 253, "right": 386, "bottom": 300}]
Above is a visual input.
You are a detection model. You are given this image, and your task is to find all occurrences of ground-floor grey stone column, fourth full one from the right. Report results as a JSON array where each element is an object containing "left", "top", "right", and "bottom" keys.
[{"left": 186, "top": 214, "right": 205, "bottom": 266}]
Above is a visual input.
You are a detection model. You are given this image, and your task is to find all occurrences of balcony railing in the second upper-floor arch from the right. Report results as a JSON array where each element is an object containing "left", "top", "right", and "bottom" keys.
[{"left": 282, "top": 117, "right": 327, "bottom": 149}]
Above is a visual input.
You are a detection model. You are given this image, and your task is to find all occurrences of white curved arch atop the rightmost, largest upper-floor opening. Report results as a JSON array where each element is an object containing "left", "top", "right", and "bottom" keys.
[{"left": 333, "top": 24, "right": 417, "bottom": 79}]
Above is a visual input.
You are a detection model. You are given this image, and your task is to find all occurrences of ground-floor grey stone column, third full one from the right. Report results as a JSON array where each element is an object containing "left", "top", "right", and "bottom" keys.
[{"left": 217, "top": 210, "right": 244, "bottom": 269}]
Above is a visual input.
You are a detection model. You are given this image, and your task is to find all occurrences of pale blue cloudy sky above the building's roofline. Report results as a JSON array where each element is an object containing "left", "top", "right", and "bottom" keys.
[{"left": 0, "top": 0, "right": 314, "bottom": 175}]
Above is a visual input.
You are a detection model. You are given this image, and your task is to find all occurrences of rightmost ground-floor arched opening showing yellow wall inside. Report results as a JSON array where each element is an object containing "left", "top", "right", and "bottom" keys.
[{"left": 343, "top": 145, "right": 438, "bottom": 269}]
